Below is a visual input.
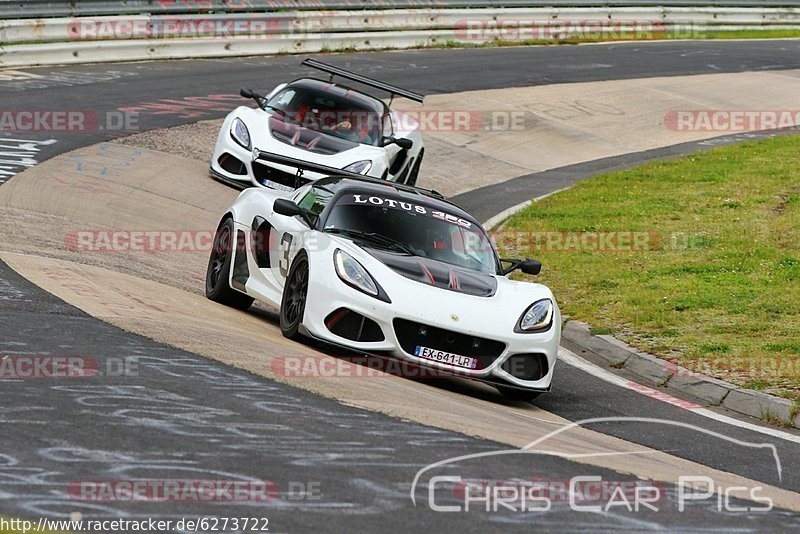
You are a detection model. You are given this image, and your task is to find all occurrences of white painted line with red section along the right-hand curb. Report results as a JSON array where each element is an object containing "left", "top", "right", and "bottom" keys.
[{"left": 558, "top": 347, "right": 800, "bottom": 444}]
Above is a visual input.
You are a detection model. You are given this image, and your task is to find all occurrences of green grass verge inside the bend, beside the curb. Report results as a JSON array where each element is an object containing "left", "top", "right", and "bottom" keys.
[{"left": 499, "top": 135, "right": 800, "bottom": 399}]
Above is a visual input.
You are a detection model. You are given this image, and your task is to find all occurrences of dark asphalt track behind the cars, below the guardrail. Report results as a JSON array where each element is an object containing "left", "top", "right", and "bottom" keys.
[{"left": 0, "top": 40, "right": 800, "bottom": 166}]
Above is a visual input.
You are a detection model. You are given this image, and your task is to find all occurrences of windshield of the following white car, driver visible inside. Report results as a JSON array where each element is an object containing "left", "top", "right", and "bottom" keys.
[{"left": 267, "top": 87, "right": 382, "bottom": 146}]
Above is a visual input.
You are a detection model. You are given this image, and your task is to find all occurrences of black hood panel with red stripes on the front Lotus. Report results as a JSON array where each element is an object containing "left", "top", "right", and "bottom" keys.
[{"left": 362, "top": 247, "right": 497, "bottom": 297}]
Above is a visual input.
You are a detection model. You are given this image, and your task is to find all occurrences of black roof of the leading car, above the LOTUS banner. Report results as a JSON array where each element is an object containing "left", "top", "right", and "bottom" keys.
[{"left": 312, "top": 176, "right": 482, "bottom": 227}]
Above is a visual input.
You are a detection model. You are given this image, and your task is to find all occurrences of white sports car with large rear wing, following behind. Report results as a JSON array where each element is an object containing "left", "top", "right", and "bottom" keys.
[{"left": 210, "top": 59, "right": 425, "bottom": 191}]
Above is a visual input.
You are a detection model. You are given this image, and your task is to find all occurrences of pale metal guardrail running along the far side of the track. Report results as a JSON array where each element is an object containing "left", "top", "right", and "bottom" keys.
[{"left": 0, "top": 4, "right": 800, "bottom": 67}]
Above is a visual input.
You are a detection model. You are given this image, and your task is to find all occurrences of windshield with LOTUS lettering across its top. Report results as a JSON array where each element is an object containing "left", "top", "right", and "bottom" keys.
[{"left": 323, "top": 194, "right": 497, "bottom": 274}]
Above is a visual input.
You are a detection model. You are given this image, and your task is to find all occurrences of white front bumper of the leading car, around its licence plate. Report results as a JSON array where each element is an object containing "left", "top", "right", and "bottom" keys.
[{"left": 303, "top": 253, "right": 561, "bottom": 391}]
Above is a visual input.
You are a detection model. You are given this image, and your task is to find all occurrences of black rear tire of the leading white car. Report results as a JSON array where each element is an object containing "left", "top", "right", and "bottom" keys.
[{"left": 206, "top": 217, "right": 254, "bottom": 310}]
